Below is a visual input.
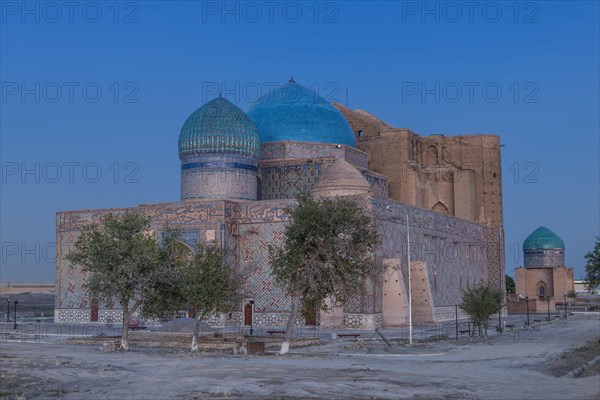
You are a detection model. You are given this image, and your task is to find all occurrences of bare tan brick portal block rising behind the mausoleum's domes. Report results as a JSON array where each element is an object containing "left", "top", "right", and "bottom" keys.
[{"left": 336, "top": 104, "right": 504, "bottom": 227}]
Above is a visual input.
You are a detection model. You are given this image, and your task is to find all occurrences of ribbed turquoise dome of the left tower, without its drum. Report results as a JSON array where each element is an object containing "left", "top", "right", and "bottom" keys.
[{"left": 179, "top": 97, "right": 260, "bottom": 159}]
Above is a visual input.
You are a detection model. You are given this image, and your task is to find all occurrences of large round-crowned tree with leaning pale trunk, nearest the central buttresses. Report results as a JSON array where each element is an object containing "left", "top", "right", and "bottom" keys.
[{"left": 270, "top": 196, "right": 383, "bottom": 354}]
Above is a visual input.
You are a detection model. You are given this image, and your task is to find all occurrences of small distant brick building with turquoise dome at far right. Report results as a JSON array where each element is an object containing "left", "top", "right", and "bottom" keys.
[{"left": 509, "top": 226, "right": 575, "bottom": 312}]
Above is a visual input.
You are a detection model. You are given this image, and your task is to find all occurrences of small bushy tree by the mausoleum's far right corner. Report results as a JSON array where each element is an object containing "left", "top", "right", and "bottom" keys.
[{"left": 459, "top": 284, "right": 502, "bottom": 338}]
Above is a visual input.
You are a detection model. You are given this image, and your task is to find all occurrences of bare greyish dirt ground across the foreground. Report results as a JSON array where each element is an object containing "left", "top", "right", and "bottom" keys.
[{"left": 0, "top": 315, "right": 600, "bottom": 400}]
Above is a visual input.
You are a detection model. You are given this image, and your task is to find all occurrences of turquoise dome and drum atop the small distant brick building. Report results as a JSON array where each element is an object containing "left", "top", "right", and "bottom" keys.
[{"left": 523, "top": 226, "right": 565, "bottom": 268}]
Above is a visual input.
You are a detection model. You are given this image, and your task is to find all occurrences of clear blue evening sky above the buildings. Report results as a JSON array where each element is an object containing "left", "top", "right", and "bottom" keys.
[{"left": 0, "top": 1, "right": 600, "bottom": 280}]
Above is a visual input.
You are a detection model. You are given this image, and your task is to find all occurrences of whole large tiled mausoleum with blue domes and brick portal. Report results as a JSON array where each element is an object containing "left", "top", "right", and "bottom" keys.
[{"left": 55, "top": 79, "right": 504, "bottom": 328}]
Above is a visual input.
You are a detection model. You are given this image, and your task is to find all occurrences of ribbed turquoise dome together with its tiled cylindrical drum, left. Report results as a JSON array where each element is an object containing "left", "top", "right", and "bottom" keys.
[{"left": 179, "top": 97, "right": 260, "bottom": 201}]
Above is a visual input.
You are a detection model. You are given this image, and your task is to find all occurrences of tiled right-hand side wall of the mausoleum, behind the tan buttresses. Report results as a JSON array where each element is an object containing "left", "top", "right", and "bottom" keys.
[{"left": 372, "top": 198, "right": 499, "bottom": 307}]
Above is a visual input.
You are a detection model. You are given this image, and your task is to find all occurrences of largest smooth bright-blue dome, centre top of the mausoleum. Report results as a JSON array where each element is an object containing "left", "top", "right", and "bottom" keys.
[{"left": 248, "top": 79, "right": 356, "bottom": 147}]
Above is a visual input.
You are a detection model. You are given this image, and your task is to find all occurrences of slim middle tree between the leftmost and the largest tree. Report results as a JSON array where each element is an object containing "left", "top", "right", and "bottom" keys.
[{"left": 181, "top": 245, "right": 236, "bottom": 351}]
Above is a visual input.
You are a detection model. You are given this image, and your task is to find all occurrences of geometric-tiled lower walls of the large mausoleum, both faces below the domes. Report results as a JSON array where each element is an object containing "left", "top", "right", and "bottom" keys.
[{"left": 56, "top": 195, "right": 504, "bottom": 324}]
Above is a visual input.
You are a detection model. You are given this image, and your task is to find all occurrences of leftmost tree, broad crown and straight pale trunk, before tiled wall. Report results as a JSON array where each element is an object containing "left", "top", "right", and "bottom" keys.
[{"left": 66, "top": 212, "right": 182, "bottom": 350}]
